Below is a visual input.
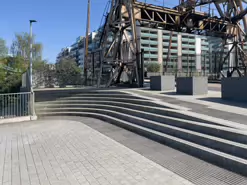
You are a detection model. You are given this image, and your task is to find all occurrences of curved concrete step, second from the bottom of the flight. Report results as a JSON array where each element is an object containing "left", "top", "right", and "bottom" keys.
[{"left": 37, "top": 107, "right": 247, "bottom": 159}]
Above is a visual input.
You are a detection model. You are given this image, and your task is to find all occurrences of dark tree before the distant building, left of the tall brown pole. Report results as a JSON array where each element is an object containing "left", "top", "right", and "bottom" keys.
[{"left": 56, "top": 59, "right": 82, "bottom": 87}]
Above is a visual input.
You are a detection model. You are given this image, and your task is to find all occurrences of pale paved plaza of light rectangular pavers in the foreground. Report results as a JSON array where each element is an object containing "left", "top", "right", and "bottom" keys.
[{"left": 0, "top": 120, "right": 192, "bottom": 185}]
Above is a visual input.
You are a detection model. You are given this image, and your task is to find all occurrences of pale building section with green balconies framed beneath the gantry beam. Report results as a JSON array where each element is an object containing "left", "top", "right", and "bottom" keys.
[{"left": 139, "top": 27, "right": 222, "bottom": 72}]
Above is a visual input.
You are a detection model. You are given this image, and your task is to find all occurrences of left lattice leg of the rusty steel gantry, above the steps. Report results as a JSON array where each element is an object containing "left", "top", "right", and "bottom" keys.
[{"left": 98, "top": 0, "right": 140, "bottom": 87}]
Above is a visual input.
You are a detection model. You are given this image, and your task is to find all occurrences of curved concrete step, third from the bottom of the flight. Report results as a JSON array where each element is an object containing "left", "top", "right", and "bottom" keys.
[{"left": 36, "top": 102, "right": 247, "bottom": 144}]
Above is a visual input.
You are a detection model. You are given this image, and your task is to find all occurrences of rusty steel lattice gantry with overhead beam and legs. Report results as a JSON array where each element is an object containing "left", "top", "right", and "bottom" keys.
[{"left": 86, "top": 0, "right": 247, "bottom": 87}]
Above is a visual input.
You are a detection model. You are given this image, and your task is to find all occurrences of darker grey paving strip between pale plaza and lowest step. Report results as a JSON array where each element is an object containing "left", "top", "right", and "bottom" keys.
[{"left": 61, "top": 117, "right": 247, "bottom": 185}]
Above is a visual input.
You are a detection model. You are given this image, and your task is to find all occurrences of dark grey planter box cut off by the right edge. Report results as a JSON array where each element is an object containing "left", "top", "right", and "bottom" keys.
[{"left": 221, "top": 77, "right": 247, "bottom": 101}]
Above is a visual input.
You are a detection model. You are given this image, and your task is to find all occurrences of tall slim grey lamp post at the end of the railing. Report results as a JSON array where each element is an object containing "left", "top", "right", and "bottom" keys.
[{"left": 29, "top": 20, "right": 37, "bottom": 120}]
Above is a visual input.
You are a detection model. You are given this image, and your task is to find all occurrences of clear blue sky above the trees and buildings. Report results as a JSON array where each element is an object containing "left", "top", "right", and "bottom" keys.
[{"left": 0, "top": 0, "right": 178, "bottom": 63}]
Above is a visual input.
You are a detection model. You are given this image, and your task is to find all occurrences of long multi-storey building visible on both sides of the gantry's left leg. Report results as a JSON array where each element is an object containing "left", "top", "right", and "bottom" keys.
[{"left": 57, "top": 27, "right": 247, "bottom": 74}]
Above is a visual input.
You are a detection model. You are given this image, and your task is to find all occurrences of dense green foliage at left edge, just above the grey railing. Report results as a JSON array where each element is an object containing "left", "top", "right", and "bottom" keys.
[{"left": 0, "top": 57, "right": 27, "bottom": 93}]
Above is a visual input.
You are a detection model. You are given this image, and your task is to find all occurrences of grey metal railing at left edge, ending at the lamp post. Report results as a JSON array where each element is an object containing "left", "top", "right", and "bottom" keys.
[{"left": 0, "top": 92, "right": 33, "bottom": 119}]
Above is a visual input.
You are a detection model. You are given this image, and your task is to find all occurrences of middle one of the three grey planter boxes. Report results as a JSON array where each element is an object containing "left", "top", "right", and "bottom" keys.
[{"left": 177, "top": 76, "right": 208, "bottom": 95}]
